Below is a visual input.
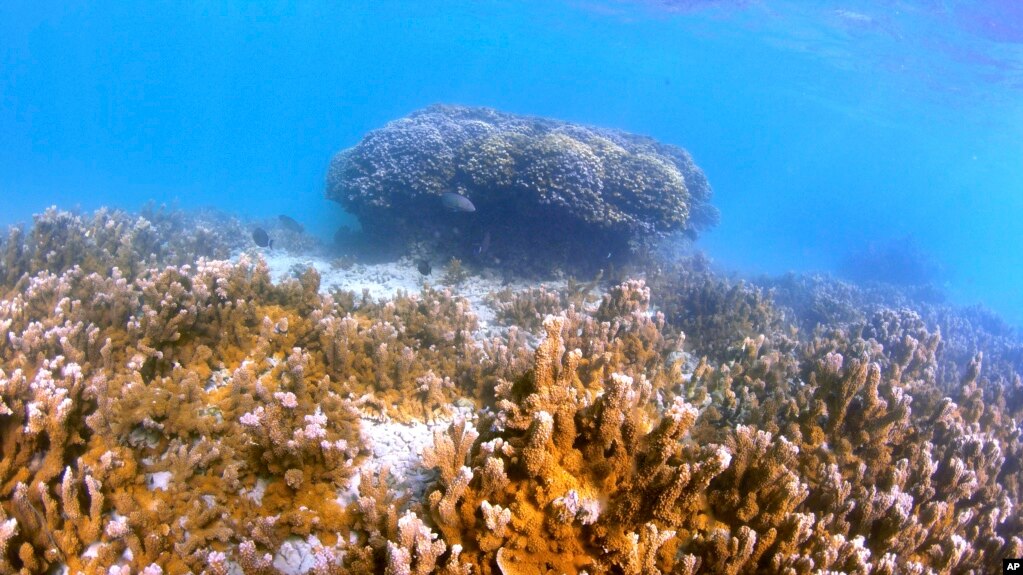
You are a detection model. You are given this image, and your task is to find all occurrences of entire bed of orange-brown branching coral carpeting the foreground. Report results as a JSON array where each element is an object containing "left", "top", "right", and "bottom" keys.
[{"left": 0, "top": 202, "right": 1023, "bottom": 575}]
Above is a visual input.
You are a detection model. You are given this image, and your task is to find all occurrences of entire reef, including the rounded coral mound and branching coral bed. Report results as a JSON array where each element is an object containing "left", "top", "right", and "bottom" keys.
[{"left": 0, "top": 106, "right": 1023, "bottom": 575}]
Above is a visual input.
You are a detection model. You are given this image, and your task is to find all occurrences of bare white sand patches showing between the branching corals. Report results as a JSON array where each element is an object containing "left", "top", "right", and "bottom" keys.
[{"left": 226, "top": 251, "right": 599, "bottom": 575}]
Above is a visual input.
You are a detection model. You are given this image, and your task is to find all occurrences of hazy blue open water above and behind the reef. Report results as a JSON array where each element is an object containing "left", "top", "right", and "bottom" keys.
[{"left": 0, "top": 0, "right": 1023, "bottom": 322}]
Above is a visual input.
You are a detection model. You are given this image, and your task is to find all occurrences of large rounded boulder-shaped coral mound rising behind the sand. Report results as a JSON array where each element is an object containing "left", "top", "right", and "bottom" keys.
[{"left": 326, "top": 105, "right": 717, "bottom": 269}]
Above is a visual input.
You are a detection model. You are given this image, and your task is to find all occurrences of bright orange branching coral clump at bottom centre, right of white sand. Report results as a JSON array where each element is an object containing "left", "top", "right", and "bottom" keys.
[{"left": 415, "top": 304, "right": 729, "bottom": 573}]
